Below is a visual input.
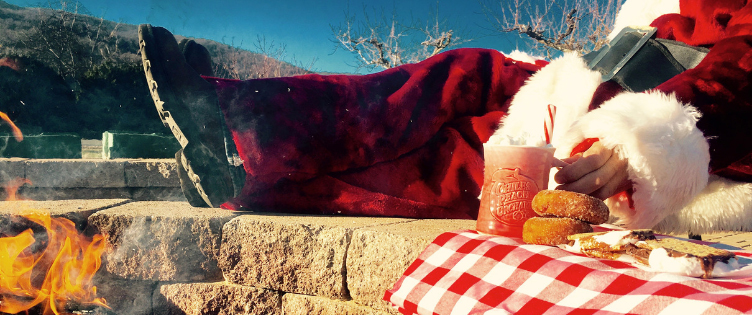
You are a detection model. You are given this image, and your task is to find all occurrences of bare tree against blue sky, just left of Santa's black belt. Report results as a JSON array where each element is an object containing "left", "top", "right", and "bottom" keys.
[{"left": 481, "top": 0, "right": 621, "bottom": 58}]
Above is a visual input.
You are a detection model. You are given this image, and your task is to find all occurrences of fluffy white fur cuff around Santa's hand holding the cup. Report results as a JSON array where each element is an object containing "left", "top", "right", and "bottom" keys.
[{"left": 558, "top": 92, "right": 710, "bottom": 228}]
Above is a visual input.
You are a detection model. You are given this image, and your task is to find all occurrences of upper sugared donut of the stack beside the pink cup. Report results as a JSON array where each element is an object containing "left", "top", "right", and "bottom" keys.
[{"left": 533, "top": 190, "right": 609, "bottom": 224}]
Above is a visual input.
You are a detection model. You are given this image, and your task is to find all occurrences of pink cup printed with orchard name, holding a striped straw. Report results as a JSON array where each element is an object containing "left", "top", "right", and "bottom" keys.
[{"left": 476, "top": 144, "right": 554, "bottom": 237}]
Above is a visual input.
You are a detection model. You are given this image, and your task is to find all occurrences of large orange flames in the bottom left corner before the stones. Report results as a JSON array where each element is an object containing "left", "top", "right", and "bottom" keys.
[{"left": 0, "top": 211, "right": 107, "bottom": 314}]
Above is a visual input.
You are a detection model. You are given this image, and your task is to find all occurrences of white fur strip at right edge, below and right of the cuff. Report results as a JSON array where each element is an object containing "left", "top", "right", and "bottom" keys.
[{"left": 655, "top": 175, "right": 752, "bottom": 234}]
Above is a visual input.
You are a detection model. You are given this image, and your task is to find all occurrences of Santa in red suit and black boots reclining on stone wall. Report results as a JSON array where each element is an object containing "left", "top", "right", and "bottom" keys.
[{"left": 140, "top": 0, "right": 752, "bottom": 233}]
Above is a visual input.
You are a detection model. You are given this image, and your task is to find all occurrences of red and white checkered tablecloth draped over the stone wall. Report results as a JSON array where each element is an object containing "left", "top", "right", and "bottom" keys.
[{"left": 384, "top": 231, "right": 752, "bottom": 315}]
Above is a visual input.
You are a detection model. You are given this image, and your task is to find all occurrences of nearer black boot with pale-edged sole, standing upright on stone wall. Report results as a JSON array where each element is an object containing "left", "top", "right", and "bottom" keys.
[{"left": 138, "top": 25, "right": 235, "bottom": 207}]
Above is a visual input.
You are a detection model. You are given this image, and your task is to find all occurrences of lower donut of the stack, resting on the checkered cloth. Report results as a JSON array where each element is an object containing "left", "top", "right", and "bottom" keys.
[{"left": 522, "top": 217, "right": 593, "bottom": 246}]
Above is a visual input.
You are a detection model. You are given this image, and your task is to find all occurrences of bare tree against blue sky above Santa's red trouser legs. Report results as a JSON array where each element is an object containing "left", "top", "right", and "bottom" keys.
[{"left": 331, "top": 6, "right": 469, "bottom": 69}]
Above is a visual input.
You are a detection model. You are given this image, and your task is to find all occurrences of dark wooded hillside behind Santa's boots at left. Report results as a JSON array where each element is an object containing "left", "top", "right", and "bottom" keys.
[{"left": 0, "top": 0, "right": 320, "bottom": 139}]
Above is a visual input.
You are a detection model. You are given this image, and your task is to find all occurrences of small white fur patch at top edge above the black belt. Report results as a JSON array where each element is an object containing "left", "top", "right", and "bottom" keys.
[{"left": 608, "top": 0, "right": 679, "bottom": 40}]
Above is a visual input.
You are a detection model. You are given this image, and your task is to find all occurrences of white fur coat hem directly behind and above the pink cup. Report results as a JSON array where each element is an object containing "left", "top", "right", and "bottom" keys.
[{"left": 488, "top": 54, "right": 601, "bottom": 149}]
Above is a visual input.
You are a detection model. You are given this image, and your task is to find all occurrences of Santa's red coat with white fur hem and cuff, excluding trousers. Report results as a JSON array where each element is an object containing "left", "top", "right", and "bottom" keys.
[{"left": 498, "top": 0, "right": 752, "bottom": 233}]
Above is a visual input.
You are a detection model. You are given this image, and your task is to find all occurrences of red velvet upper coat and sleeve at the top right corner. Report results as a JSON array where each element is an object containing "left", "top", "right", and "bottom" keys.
[{"left": 652, "top": 0, "right": 752, "bottom": 181}]
